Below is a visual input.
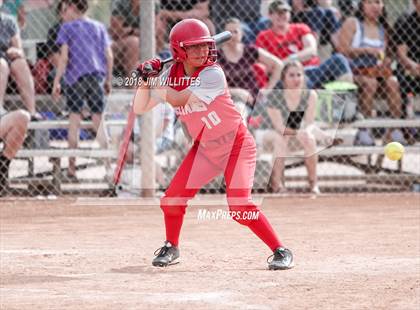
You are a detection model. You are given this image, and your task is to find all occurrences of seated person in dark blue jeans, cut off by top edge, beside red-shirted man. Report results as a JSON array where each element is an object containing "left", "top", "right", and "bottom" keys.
[{"left": 292, "top": 0, "right": 340, "bottom": 45}]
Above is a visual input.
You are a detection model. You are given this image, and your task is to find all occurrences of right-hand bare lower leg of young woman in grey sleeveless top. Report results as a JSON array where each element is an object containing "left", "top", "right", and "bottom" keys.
[{"left": 296, "top": 131, "right": 318, "bottom": 191}]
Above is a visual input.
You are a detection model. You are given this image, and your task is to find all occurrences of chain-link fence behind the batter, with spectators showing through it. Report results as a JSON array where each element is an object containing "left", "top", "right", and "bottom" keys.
[{"left": 0, "top": 0, "right": 420, "bottom": 196}]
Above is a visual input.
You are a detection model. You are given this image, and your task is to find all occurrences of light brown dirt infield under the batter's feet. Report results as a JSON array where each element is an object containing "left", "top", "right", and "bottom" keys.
[{"left": 0, "top": 194, "right": 420, "bottom": 310}]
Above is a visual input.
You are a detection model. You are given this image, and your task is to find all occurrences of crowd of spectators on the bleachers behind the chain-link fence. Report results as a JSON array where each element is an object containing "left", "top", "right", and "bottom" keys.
[{"left": 0, "top": 0, "right": 420, "bottom": 193}]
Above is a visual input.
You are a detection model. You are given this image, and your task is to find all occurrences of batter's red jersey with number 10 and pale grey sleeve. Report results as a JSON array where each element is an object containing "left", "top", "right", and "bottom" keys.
[{"left": 169, "top": 63, "right": 242, "bottom": 143}]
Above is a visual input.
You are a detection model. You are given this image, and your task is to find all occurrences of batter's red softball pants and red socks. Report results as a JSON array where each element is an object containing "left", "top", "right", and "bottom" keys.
[{"left": 161, "top": 124, "right": 282, "bottom": 251}]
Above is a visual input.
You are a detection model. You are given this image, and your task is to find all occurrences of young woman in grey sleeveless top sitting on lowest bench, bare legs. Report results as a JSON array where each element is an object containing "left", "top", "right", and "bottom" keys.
[{"left": 267, "top": 61, "right": 340, "bottom": 194}]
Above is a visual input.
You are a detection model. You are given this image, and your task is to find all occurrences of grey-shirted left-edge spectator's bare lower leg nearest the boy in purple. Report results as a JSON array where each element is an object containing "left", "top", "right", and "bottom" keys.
[{"left": 10, "top": 58, "right": 36, "bottom": 115}]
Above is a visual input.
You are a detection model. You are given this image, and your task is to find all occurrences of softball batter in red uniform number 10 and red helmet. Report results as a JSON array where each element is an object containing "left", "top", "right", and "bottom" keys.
[{"left": 134, "top": 19, "right": 293, "bottom": 269}]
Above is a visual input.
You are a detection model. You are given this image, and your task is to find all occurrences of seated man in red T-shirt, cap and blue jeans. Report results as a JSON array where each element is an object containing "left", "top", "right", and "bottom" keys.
[{"left": 256, "top": 0, "right": 353, "bottom": 88}]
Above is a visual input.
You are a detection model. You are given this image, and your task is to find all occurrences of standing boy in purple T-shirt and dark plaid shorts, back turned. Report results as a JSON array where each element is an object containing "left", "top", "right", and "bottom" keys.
[{"left": 52, "top": 0, "right": 113, "bottom": 178}]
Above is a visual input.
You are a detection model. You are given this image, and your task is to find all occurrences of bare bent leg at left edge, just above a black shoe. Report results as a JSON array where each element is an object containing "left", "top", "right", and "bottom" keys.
[{"left": 0, "top": 110, "right": 30, "bottom": 159}]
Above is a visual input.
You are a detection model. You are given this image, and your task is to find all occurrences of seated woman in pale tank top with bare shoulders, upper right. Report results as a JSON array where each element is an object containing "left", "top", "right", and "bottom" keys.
[{"left": 337, "top": 0, "right": 405, "bottom": 145}]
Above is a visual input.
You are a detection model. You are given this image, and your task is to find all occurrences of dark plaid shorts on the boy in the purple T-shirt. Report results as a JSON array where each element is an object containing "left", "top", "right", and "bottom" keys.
[{"left": 64, "top": 73, "right": 105, "bottom": 114}]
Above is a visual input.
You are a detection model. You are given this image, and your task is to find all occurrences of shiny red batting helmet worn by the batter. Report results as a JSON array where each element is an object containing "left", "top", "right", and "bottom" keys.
[{"left": 169, "top": 18, "right": 217, "bottom": 66}]
